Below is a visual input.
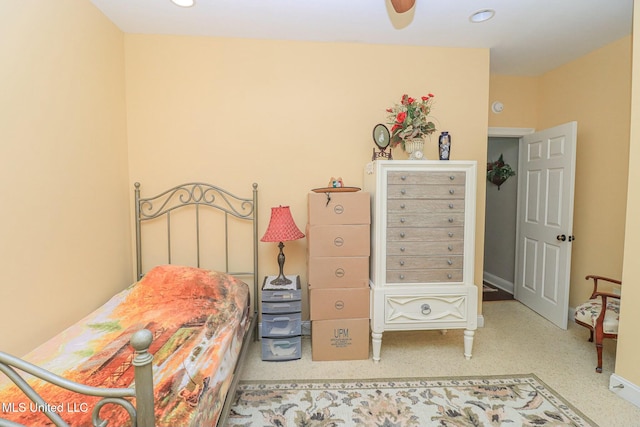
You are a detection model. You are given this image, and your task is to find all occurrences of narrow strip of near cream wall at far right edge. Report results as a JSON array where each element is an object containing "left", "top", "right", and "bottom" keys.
[{"left": 615, "top": 0, "right": 640, "bottom": 390}]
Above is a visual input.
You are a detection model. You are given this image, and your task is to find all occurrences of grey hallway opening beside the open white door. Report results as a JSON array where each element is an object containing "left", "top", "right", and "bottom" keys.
[{"left": 482, "top": 134, "right": 520, "bottom": 301}]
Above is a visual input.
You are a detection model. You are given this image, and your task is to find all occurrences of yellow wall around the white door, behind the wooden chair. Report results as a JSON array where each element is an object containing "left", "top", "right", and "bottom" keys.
[{"left": 489, "top": 37, "right": 631, "bottom": 307}]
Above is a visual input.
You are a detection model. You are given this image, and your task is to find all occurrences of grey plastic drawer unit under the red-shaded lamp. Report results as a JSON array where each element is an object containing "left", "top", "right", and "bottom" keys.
[{"left": 260, "top": 275, "right": 302, "bottom": 361}]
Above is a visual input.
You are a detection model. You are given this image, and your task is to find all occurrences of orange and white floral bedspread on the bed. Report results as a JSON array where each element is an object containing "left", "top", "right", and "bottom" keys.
[{"left": 0, "top": 266, "right": 250, "bottom": 427}]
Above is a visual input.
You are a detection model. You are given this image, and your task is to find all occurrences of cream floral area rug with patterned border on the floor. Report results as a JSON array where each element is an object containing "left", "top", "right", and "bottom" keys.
[{"left": 226, "top": 374, "right": 596, "bottom": 427}]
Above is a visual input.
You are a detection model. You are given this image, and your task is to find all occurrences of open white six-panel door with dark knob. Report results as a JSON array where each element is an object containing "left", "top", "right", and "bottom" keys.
[{"left": 514, "top": 122, "right": 578, "bottom": 329}]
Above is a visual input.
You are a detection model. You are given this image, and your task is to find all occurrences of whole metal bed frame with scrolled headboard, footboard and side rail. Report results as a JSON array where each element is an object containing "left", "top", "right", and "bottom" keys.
[{"left": 0, "top": 182, "right": 258, "bottom": 427}]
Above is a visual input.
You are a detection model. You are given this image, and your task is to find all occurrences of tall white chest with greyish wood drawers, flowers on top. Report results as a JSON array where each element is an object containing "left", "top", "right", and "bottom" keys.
[{"left": 364, "top": 160, "right": 478, "bottom": 362}]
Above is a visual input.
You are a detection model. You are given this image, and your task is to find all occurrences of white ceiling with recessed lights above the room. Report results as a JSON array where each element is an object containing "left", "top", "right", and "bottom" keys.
[{"left": 91, "top": 0, "right": 633, "bottom": 76}]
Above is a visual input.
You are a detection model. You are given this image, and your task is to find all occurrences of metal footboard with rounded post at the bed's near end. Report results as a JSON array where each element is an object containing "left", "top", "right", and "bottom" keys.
[{"left": 0, "top": 329, "right": 155, "bottom": 427}]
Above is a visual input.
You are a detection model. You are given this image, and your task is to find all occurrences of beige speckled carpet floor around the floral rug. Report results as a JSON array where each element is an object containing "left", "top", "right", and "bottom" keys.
[{"left": 240, "top": 301, "right": 640, "bottom": 427}]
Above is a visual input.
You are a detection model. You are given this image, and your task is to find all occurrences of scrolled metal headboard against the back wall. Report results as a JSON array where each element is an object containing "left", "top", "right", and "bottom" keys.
[{"left": 134, "top": 182, "right": 258, "bottom": 290}]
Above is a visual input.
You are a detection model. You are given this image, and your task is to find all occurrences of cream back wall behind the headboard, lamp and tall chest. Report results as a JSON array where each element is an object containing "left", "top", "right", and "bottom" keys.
[{"left": 125, "top": 34, "right": 489, "bottom": 314}]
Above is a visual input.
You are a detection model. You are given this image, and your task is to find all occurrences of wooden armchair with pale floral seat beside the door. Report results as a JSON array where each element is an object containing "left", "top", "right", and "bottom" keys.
[{"left": 575, "top": 275, "right": 622, "bottom": 373}]
